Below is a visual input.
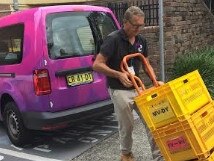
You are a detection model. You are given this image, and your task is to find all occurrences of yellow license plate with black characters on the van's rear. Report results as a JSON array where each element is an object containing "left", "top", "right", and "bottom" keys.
[{"left": 66, "top": 72, "right": 94, "bottom": 86}]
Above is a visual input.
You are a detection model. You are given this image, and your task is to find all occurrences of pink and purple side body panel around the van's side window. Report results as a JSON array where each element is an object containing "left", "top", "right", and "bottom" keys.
[{"left": 0, "top": 10, "right": 50, "bottom": 112}]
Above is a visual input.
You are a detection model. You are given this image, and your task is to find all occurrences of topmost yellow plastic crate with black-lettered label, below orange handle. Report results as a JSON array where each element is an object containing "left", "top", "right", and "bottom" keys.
[{"left": 134, "top": 70, "right": 212, "bottom": 130}]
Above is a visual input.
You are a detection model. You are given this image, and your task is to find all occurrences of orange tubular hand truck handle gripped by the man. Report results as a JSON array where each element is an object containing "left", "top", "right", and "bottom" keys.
[{"left": 120, "top": 53, "right": 159, "bottom": 95}]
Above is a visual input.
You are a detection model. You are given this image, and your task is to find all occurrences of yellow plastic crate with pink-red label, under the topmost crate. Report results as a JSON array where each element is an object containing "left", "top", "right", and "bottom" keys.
[{"left": 152, "top": 102, "right": 214, "bottom": 161}]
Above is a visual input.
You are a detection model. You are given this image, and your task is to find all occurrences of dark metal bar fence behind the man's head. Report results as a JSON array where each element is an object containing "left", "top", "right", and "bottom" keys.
[{"left": 107, "top": 0, "right": 159, "bottom": 26}]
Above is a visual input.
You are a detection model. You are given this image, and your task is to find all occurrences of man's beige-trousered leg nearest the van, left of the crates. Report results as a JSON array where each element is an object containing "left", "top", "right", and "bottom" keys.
[{"left": 109, "top": 89, "right": 134, "bottom": 154}]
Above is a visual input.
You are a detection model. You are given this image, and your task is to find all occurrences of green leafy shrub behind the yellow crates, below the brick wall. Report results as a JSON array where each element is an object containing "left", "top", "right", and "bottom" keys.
[{"left": 170, "top": 47, "right": 214, "bottom": 98}]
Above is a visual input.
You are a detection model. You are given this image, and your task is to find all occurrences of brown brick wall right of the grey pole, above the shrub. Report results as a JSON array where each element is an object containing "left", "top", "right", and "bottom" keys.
[{"left": 164, "top": 0, "right": 214, "bottom": 80}]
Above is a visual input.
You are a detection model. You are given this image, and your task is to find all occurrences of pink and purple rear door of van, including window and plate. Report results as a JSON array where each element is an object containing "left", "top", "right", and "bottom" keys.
[{"left": 46, "top": 11, "right": 117, "bottom": 111}]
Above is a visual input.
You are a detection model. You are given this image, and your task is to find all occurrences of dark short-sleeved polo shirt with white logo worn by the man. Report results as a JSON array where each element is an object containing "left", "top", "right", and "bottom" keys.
[{"left": 100, "top": 29, "right": 148, "bottom": 89}]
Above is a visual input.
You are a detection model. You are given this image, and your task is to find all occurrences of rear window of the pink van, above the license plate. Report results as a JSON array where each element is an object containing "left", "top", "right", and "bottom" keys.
[{"left": 46, "top": 12, "right": 116, "bottom": 59}]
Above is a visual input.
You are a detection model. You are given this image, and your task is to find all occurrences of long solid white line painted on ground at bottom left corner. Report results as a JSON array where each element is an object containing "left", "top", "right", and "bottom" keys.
[{"left": 0, "top": 148, "right": 62, "bottom": 161}]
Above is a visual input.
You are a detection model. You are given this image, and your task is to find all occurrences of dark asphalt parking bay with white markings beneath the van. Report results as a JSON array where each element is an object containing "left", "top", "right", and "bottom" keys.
[{"left": 0, "top": 114, "right": 118, "bottom": 161}]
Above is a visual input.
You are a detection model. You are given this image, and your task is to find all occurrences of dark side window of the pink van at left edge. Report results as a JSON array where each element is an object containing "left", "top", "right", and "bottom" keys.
[{"left": 0, "top": 24, "right": 24, "bottom": 65}]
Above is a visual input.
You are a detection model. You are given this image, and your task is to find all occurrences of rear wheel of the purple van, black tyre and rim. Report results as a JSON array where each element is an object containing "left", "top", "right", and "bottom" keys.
[{"left": 4, "top": 102, "right": 29, "bottom": 146}]
